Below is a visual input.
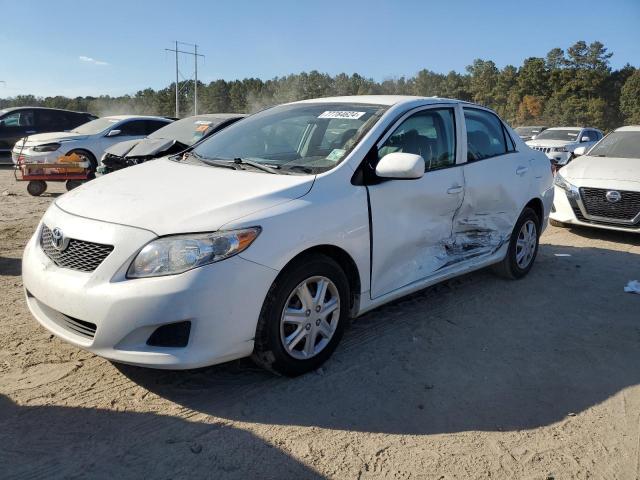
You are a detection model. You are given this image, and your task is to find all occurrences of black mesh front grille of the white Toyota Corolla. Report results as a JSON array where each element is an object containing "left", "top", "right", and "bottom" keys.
[{"left": 40, "top": 225, "right": 113, "bottom": 272}]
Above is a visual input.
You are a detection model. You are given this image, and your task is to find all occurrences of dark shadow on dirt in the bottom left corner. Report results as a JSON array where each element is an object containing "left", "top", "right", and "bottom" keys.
[{"left": 0, "top": 395, "right": 323, "bottom": 479}]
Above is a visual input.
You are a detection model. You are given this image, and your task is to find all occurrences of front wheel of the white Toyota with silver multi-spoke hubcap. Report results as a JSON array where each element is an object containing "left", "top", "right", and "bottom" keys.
[{"left": 252, "top": 255, "right": 350, "bottom": 377}]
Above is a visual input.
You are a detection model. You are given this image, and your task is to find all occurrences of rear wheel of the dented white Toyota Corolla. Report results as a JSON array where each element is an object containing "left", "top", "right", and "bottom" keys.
[{"left": 493, "top": 207, "right": 540, "bottom": 280}]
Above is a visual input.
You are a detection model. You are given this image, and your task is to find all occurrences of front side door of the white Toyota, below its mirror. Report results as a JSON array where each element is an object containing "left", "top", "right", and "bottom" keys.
[{"left": 368, "top": 106, "right": 464, "bottom": 298}]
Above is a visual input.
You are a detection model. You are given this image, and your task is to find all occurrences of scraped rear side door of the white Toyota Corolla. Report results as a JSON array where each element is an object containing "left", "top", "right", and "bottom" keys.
[{"left": 453, "top": 107, "right": 538, "bottom": 253}]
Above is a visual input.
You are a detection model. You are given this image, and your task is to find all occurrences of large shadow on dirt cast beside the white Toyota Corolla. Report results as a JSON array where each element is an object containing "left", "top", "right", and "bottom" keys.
[{"left": 118, "top": 240, "right": 640, "bottom": 434}]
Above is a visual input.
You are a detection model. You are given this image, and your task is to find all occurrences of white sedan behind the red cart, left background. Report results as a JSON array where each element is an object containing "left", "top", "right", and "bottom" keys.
[{"left": 12, "top": 115, "right": 173, "bottom": 170}]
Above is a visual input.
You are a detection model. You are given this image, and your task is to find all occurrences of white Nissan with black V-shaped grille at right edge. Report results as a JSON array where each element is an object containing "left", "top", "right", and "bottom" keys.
[{"left": 551, "top": 126, "right": 640, "bottom": 233}]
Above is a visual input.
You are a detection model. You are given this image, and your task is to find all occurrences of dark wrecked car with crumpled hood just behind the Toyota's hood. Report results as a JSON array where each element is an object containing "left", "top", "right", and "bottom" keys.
[{"left": 98, "top": 113, "right": 246, "bottom": 174}]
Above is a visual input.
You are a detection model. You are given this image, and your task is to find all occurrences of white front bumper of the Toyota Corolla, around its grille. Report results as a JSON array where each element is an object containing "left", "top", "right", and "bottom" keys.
[{"left": 22, "top": 205, "right": 278, "bottom": 369}]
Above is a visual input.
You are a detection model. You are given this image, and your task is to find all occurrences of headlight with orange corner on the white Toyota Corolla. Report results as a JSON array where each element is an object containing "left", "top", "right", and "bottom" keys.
[{"left": 127, "top": 227, "right": 261, "bottom": 278}]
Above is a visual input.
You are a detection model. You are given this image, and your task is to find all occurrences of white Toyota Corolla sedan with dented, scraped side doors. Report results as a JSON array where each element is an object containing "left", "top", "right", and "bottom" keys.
[{"left": 23, "top": 96, "right": 553, "bottom": 375}]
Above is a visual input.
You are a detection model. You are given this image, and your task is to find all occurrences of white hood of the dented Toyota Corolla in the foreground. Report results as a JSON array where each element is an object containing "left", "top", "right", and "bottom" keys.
[{"left": 56, "top": 158, "right": 315, "bottom": 235}]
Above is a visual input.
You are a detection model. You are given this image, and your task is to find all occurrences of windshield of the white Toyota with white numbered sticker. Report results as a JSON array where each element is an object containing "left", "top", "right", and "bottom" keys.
[{"left": 194, "top": 103, "right": 386, "bottom": 173}]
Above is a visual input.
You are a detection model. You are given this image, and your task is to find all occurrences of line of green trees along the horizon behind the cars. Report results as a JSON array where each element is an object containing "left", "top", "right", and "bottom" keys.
[{"left": 0, "top": 41, "right": 640, "bottom": 130}]
